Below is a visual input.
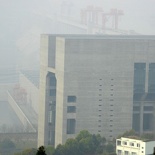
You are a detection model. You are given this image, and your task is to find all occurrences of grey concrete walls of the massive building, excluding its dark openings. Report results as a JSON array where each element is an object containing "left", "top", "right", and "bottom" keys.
[{"left": 39, "top": 35, "right": 155, "bottom": 145}]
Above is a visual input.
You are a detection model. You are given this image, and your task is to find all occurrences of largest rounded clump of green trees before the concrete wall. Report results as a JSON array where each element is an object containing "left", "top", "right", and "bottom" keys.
[{"left": 53, "top": 130, "right": 109, "bottom": 155}]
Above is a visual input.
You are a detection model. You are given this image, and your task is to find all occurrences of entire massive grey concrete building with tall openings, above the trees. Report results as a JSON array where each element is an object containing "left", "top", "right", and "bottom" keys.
[{"left": 38, "top": 35, "right": 155, "bottom": 145}]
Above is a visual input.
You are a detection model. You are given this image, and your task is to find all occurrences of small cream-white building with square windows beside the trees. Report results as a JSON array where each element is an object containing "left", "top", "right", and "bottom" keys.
[{"left": 116, "top": 137, "right": 155, "bottom": 155}]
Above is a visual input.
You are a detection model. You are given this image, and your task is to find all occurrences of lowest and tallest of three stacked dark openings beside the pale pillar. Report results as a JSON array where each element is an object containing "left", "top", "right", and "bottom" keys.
[{"left": 67, "top": 119, "right": 76, "bottom": 134}]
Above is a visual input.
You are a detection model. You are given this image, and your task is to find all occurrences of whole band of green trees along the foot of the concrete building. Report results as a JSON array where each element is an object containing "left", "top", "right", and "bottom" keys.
[{"left": 13, "top": 130, "right": 155, "bottom": 155}]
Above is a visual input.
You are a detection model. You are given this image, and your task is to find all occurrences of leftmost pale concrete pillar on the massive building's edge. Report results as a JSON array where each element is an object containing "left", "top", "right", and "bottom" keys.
[{"left": 38, "top": 35, "right": 49, "bottom": 146}]
